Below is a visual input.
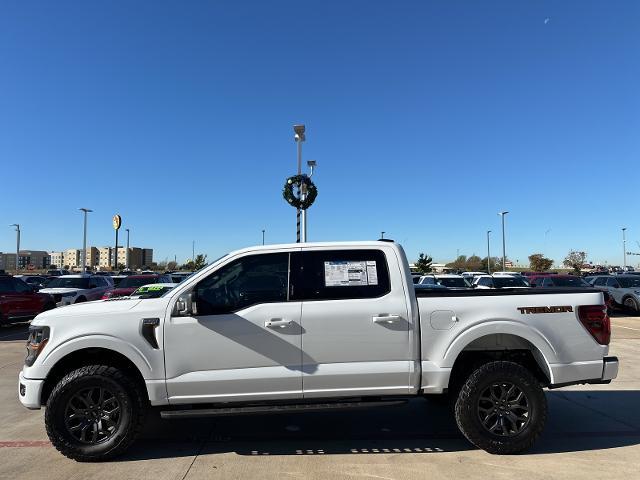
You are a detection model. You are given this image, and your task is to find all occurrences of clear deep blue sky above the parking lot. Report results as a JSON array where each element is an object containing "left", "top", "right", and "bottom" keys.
[{"left": 0, "top": 0, "right": 640, "bottom": 264}]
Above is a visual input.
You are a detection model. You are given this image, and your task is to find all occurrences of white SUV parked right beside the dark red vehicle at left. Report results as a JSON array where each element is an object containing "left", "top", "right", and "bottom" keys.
[{"left": 40, "top": 274, "right": 113, "bottom": 307}]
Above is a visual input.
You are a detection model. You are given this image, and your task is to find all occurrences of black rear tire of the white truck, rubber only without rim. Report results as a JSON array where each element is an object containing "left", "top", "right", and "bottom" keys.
[{"left": 455, "top": 361, "right": 547, "bottom": 455}]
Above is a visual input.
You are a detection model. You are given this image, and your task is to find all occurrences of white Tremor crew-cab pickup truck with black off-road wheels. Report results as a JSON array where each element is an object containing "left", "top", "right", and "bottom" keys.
[{"left": 19, "top": 241, "right": 618, "bottom": 461}]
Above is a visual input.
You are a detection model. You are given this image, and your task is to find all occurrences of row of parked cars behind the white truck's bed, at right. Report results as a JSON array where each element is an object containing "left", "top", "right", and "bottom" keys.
[{"left": 413, "top": 272, "right": 640, "bottom": 314}]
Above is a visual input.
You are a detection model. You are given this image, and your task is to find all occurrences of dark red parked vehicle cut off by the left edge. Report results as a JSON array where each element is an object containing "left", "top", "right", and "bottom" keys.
[{"left": 0, "top": 275, "right": 56, "bottom": 325}]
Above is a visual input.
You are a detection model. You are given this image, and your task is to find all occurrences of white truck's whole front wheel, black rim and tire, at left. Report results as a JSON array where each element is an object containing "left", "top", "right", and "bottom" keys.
[{"left": 45, "top": 365, "right": 146, "bottom": 462}]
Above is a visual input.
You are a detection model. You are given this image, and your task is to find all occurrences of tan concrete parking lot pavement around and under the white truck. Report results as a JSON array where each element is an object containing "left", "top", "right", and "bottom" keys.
[{"left": 0, "top": 317, "right": 640, "bottom": 480}]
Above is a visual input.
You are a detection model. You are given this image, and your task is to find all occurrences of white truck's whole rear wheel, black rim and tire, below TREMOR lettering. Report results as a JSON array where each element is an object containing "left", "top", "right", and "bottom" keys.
[{"left": 455, "top": 361, "right": 547, "bottom": 454}]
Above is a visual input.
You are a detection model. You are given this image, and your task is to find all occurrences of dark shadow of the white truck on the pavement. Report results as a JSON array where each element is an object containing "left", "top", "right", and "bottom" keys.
[{"left": 119, "top": 390, "right": 640, "bottom": 461}]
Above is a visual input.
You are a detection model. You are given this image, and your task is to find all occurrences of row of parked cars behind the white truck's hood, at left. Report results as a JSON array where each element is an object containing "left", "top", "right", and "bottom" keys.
[{"left": 0, "top": 272, "right": 190, "bottom": 325}]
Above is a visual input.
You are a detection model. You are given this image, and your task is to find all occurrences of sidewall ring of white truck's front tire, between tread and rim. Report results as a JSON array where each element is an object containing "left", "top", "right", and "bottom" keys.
[{"left": 45, "top": 375, "right": 135, "bottom": 457}]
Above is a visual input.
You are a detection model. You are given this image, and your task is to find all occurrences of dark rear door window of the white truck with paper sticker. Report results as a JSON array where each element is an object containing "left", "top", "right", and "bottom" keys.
[{"left": 291, "top": 249, "right": 391, "bottom": 300}]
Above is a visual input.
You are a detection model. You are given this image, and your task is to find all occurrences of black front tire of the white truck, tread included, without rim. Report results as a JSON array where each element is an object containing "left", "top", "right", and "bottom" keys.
[{"left": 45, "top": 365, "right": 147, "bottom": 462}]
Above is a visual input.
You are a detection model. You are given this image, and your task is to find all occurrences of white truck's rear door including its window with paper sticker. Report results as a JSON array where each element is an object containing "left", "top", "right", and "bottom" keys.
[{"left": 292, "top": 248, "right": 414, "bottom": 398}]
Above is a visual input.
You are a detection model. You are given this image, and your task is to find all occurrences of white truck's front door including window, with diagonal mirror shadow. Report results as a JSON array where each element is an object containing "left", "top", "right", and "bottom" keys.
[{"left": 164, "top": 252, "right": 302, "bottom": 403}]
